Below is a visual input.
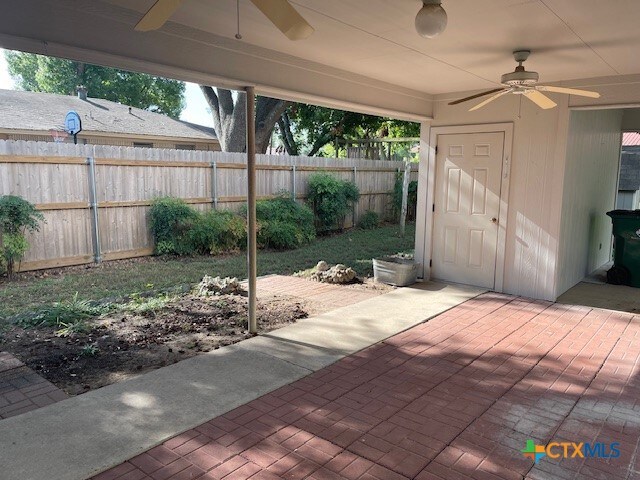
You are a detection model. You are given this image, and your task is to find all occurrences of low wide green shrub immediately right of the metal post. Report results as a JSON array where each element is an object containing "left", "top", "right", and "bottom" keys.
[{"left": 242, "top": 194, "right": 316, "bottom": 250}]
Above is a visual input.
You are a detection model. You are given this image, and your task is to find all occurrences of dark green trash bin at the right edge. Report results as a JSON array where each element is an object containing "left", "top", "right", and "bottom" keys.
[{"left": 607, "top": 210, "right": 640, "bottom": 287}]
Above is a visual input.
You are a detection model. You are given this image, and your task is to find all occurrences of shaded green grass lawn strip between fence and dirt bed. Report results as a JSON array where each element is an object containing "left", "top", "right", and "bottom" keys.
[{"left": 0, "top": 225, "right": 415, "bottom": 318}]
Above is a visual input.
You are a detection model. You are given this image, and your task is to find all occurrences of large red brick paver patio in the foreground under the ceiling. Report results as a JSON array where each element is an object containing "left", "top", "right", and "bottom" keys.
[{"left": 95, "top": 294, "right": 640, "bottom": 480}]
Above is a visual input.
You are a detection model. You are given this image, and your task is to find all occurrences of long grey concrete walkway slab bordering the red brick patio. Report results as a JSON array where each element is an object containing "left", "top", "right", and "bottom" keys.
[{"left": 0, "top": 283, "right": 482, "bottom": 480}]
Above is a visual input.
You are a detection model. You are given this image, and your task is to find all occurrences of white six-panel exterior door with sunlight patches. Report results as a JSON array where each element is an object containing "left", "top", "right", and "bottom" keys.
[{"left": 432, "top": 132, "right": 504, "bottom": 288}]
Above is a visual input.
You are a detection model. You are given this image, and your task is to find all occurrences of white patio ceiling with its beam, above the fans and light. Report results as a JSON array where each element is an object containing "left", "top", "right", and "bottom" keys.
[{"left": 0, "top": 0, "right": 640, "bottom": 120}]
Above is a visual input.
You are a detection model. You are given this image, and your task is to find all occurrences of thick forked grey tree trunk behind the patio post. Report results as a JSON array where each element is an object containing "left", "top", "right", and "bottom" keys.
[{"left": 200, "top": 85, "right": 290, "bottom": 153}]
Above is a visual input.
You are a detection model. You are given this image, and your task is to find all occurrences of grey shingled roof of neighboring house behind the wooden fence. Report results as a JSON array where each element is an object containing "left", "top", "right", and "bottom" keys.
[{"left": 0, "top": 89, "right": 217, "bottom": 141}]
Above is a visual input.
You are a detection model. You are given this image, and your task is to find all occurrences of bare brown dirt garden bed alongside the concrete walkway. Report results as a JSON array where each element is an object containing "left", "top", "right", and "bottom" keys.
[{"left": 0, "top": 279, "right": 392, "bottom": 395}]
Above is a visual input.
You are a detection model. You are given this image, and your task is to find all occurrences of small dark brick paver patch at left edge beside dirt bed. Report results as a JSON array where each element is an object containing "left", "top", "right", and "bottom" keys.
[{"left": 0, "top": 352, "right": 67, "bottom": 420}]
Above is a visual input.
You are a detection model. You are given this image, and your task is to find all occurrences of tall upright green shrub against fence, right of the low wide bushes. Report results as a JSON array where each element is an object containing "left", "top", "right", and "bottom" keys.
[{"left": 308, "top": 173, "right": 360, "bottom": 232}]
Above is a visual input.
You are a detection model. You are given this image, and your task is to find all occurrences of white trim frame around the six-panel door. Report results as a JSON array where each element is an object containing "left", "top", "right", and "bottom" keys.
[{"left": 416, "top": 123, "right": 513, "bottom": 292}]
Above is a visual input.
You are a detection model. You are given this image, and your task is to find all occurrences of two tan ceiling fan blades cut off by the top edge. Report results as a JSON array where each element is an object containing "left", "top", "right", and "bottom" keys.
[{"left": 135, "top": 0, "right": 314, "bottom": 40}]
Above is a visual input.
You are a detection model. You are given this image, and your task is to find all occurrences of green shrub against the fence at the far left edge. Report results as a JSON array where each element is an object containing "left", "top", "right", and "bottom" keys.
[{"left": 0, "top": 195, "right": 44, "bottom": 277}]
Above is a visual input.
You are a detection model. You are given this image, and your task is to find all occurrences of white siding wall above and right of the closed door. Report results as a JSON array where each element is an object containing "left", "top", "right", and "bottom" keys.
[{"left": 418, "top": 95, "right": 568, "bottom": 300}]
